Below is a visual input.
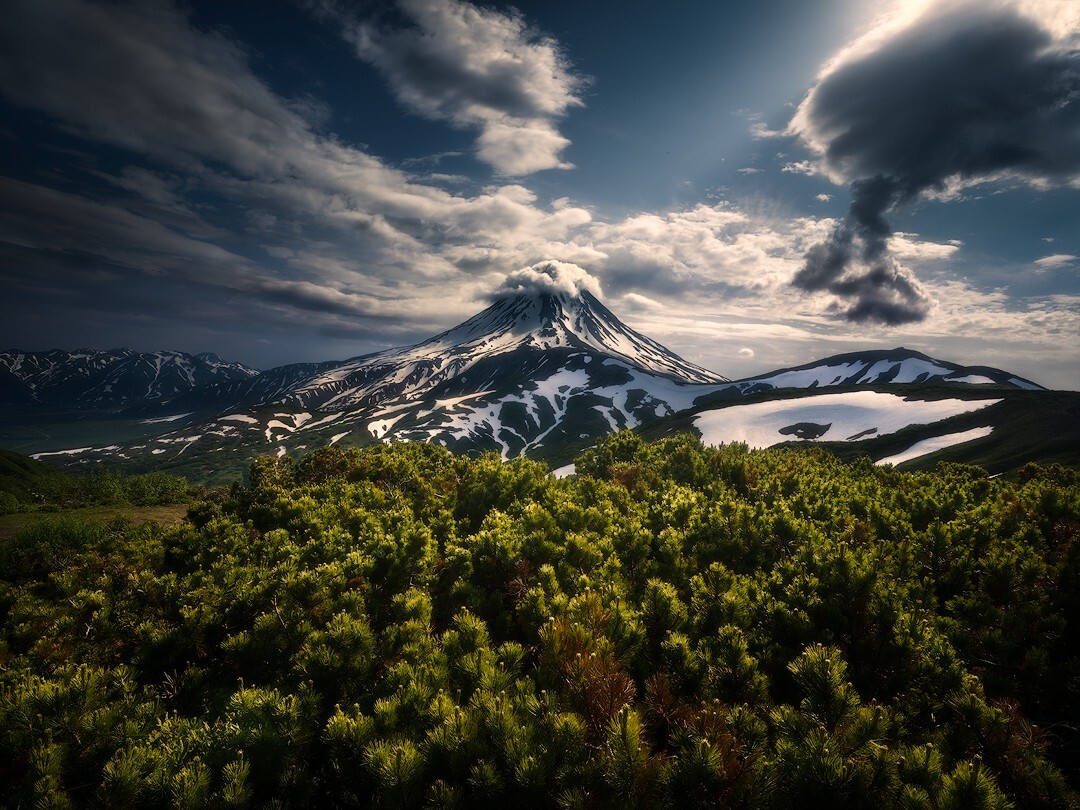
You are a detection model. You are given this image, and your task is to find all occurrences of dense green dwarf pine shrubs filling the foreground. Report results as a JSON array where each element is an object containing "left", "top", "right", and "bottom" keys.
[{"left": 0, "top": 433, "right": 1080, "bottom": 809}]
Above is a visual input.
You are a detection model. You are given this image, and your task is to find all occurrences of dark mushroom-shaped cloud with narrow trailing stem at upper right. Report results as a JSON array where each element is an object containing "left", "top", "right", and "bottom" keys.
[{"left": 792, "top": 4, "right": 1080, "bottom": 324}]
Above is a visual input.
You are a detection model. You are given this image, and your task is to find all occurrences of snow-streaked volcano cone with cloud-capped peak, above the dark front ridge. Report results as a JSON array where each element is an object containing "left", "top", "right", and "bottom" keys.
[{"left": 166, "top": 262, "right": 728, "bottom": 419}]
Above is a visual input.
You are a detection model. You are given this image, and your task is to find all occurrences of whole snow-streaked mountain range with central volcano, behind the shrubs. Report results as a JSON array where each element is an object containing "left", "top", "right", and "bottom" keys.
[{"left": 0, "top": 282, "right": 1071, "bottom": 477}]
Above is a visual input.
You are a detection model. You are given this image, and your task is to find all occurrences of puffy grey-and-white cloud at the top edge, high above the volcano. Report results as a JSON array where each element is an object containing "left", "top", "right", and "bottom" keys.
[{"left": 348, "top": 0, "right": 584, "bottom": 176}]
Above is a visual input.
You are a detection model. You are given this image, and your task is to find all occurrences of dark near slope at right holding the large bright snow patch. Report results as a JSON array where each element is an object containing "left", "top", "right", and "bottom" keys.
[{"left": 642, "top": 383, "right": 1080, "bottom": 473}]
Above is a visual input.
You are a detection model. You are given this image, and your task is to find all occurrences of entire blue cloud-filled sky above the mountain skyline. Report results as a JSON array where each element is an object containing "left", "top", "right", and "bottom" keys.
[{"left": 0, "top": 0, "right": 1080, "bottom": 390}]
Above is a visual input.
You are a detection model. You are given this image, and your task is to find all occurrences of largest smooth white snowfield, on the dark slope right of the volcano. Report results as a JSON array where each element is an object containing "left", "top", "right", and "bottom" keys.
[{"left": 693, "top": 391, "right": 1001, "bottom": 453}]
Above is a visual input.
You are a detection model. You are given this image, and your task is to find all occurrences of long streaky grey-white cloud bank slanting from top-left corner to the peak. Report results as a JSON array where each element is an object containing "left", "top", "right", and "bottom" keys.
[{"left": 0, "top": 0, "right": 593, "bottom": 339}]
